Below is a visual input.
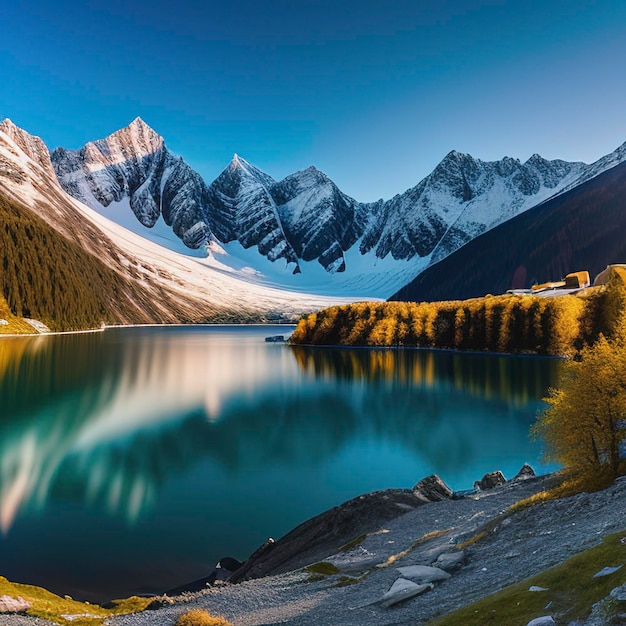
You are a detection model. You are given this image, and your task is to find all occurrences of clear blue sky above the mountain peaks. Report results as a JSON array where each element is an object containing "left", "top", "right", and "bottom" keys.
[{"left": 0, "top": 0, "right": 626, "bottom": 201}]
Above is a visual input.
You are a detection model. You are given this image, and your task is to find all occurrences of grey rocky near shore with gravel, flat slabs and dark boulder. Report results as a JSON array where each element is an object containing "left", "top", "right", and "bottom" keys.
[{"left": 2, "top": 473, "right": 626, "bottom": 626}]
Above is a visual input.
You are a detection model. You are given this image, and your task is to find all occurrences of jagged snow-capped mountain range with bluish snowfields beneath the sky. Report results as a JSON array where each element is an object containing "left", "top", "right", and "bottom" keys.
[{"left": 47, "top": 118, "right": 626, "bottom": 297}]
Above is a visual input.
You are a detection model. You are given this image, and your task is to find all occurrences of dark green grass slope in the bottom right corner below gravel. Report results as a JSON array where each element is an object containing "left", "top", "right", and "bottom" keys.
[{"left": 431, "top": 531, "right": 626, "bottom": 626}]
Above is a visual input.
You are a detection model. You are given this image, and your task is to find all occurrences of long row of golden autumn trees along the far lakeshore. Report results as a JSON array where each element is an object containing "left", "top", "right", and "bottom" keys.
[{"left": 291, "top": 268, "right": 626, "bottom": 355}]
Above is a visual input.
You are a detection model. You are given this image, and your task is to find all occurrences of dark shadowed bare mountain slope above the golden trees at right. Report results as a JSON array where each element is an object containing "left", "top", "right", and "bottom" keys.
[{"left": 390, "top": 164, "right": 626, "bottom": 301}]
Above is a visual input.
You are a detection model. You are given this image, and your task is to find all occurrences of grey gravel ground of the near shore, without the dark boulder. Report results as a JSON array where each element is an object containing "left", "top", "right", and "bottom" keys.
[{"left": 91, "top": 477, "right": 626, "bottom": 626}]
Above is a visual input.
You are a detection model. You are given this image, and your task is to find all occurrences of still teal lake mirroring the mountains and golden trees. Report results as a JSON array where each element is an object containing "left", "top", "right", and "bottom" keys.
[{"left": 0, "top": 326, "right": 560, "bottom": 601}]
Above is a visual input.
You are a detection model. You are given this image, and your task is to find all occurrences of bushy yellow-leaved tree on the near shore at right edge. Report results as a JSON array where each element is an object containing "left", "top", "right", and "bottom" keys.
[{"left": 533, "top": 320, "right": 626, "bottom": 483}]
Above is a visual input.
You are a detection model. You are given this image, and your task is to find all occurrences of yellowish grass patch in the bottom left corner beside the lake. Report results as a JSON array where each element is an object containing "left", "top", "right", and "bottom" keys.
[{"left": 0, "top": 576, "right": 150, "bottom": 626}]
